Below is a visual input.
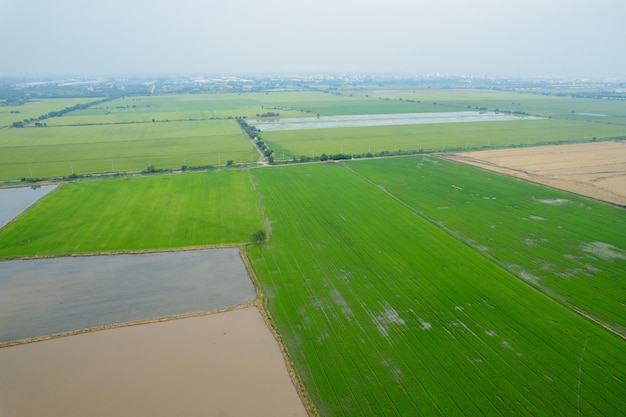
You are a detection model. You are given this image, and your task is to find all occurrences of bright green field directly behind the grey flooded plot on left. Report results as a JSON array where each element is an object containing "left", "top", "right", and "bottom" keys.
[{"left": 0, "top": 170, "right": 263, "bottom": 258}]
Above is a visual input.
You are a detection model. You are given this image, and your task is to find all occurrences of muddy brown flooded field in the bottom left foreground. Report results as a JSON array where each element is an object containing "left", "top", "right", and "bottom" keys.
[{"left": 0, "top": 307, "right": 307, "bottom": 417}]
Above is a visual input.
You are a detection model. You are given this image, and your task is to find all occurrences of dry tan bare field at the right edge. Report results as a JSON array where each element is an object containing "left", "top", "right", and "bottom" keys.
[{"left": 447, "top": 141, "right": 626, "bottom": 206}]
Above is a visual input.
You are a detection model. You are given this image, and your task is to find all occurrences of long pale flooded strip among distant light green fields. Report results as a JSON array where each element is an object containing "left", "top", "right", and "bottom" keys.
[{"left": 248, "top": 111, "right": 538, "bottom": 131}]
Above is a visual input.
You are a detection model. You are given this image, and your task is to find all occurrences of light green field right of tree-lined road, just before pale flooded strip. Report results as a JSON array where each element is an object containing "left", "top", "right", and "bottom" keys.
[{"left": 261, "top": 119, "right": 626, "bottom": 160}]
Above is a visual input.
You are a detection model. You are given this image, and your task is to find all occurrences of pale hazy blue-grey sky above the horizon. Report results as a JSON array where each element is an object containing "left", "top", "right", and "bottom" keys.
[{"left": 0, "top": 0, "right": 626, "bottom": 79}]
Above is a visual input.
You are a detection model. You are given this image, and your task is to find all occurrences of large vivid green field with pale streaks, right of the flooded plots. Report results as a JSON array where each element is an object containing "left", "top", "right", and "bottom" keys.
[{"left": 248, "top": 163, "right": 626, "bottom": 416}]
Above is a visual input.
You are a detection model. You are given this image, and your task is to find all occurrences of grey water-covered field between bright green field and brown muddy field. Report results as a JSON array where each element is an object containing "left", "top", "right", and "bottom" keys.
[{"left": 0, "top": 248, "right": 256, "bottom": 344}]
